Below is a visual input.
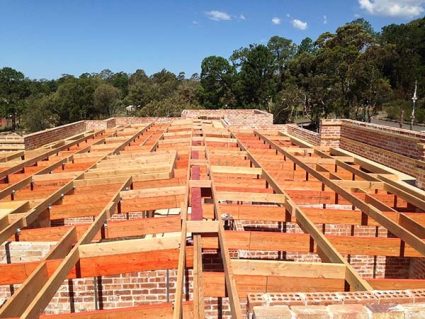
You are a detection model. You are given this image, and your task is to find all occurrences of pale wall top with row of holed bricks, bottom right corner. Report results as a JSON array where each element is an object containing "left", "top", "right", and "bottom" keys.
[{"left": 248, "top": 289, "right": 425, "bottom": 319}]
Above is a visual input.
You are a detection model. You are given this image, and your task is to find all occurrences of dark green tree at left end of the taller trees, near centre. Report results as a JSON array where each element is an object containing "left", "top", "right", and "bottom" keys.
[{"left": 200, "top": 56, "right": 235, "bottom": 109}]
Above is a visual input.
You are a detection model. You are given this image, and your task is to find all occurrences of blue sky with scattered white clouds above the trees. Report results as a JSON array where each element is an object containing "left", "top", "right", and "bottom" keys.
[{"left": 0, "top": 0, "right": 425, "bottom": 78}]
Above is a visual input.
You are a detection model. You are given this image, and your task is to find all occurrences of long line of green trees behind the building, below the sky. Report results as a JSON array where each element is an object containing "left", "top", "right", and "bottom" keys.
[{"left": 0, "top": 18, "right": 425, "bottom": 131}]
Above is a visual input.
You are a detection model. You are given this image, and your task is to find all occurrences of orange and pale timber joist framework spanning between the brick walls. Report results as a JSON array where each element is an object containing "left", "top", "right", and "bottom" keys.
[{"left": 0, "top": 119, "right": 425, "bottom": 319}]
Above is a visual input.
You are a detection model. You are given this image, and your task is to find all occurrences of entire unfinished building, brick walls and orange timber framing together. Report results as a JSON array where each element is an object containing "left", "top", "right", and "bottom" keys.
[{"left": 0, "top": 110, "right": 425, "bottom": 319}]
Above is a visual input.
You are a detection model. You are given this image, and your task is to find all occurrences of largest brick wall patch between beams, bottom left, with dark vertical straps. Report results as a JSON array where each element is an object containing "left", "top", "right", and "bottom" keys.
[{"left": 46, "top": 269, "right": 185, "bottom": 314}]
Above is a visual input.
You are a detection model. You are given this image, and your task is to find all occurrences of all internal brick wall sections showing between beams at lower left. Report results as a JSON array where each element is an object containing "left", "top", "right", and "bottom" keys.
[{"left": 0, "top": 242, "right": 193, "bottom": 314}]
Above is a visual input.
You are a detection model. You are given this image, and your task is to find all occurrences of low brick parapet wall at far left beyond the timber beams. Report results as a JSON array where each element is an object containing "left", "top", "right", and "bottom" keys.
[{"left": 24, "top": 121, "right": 86, "bottom": 150}]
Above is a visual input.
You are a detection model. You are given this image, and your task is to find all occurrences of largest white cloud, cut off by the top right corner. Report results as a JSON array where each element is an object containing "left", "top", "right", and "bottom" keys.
[{"left": 358, "top": 0, "right": 425, "bottom": 18}]
